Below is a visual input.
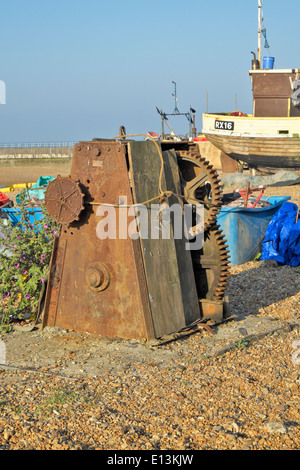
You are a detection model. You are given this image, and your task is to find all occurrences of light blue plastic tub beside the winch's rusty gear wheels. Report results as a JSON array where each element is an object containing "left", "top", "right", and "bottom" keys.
[{"left": 217, "top": 196, "right": 290, "bottom": 265}]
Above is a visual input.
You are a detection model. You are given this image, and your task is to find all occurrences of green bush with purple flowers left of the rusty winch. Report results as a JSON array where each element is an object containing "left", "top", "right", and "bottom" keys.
[{"left": 0, "top": 192, "right": 59, "bottom": 333}]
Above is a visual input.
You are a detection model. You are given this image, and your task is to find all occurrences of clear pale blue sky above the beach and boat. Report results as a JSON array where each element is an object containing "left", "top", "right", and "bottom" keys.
[{"left": 0, "top": 0, "right": 300, "bottom": 142}]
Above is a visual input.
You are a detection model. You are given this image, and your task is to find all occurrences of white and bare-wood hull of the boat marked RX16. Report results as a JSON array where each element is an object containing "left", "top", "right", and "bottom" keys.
[{"left": 202, "top": 114, "right": 300, "bottom": 169}]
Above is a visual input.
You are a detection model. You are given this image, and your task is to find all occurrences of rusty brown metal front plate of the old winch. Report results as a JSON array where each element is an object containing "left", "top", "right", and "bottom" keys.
[{"left": 43, "top": 141, "right": 154, "bottom": 338}]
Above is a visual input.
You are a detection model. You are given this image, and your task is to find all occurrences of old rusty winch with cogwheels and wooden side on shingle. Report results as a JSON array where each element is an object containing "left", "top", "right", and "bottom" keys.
[{"left": 43, "top": 135, "right": 229, "bottom": 339}]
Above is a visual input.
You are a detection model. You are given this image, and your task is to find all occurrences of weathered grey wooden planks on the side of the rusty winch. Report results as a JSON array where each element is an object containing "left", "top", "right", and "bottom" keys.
[{"left": 128, "top": 141, "right": 200, "bottom": 338}]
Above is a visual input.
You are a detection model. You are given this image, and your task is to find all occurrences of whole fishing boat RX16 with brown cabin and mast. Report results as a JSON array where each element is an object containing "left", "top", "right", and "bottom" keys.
[{"left": 202, "top": 0, "right": 300, "bottom": 170}]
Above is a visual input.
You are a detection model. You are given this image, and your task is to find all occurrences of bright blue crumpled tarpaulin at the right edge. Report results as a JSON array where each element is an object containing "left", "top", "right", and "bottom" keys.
[{"left": 261, "top": 202, "right": 300, "bottom": 266}]
